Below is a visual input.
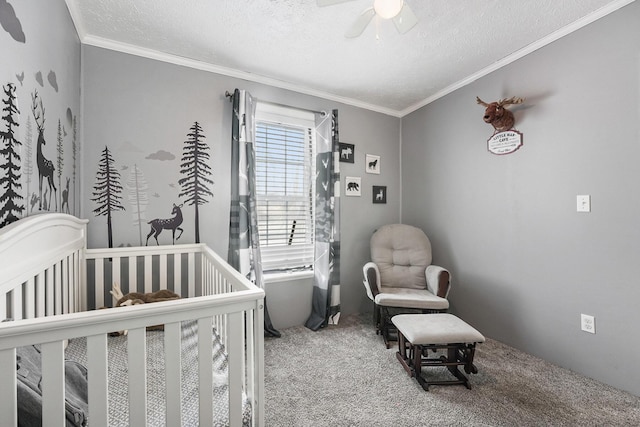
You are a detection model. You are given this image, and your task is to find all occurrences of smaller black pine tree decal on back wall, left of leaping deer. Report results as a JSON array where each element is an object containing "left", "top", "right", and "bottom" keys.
[{"left": 91, "top": 147, "right": 125, "bottom": 248}]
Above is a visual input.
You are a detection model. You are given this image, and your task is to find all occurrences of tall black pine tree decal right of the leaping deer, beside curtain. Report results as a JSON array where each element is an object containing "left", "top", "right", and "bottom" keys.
[{"left": 178, "top": 122, "right": 213, "bottom": 243}]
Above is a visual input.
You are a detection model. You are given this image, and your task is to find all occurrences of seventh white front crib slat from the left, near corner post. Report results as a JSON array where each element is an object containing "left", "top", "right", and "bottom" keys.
[{"left": 227, "top": 312, "right": 244, "bottom": 426}]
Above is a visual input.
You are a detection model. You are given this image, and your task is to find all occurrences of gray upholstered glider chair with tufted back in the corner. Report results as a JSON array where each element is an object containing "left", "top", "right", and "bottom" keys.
[{"left": 362, "top": 224, "right": 451, "bottom": 348}]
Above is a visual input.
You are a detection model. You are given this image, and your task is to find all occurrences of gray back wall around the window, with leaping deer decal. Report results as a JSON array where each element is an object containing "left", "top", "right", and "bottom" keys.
[{"left": 82, "top": 46, "right": 400, "bottom": 328}]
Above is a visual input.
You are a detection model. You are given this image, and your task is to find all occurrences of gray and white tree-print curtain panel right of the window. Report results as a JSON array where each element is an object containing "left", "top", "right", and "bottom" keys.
[{"left": 305, "top": 110, "right": 340, "bottom": 331}]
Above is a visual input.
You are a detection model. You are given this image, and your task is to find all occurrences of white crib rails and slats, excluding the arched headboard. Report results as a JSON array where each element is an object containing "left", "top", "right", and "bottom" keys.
[{"left": 0, "top": 244, "right": 264, "bottom": 426}]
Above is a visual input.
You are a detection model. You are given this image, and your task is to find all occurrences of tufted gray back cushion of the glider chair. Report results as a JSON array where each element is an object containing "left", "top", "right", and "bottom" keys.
[{"left": 371, "top": 224, "right": 431, "bottom": 289}]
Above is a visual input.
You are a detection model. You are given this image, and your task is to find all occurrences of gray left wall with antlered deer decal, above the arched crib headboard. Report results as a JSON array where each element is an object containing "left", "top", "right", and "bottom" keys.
[{"left": 0, "top": 0, "right": 82, "bottom": 224}]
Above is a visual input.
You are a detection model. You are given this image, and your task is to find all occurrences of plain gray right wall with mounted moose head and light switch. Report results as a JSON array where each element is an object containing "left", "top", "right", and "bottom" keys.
[{"left": 402, "top": 2, "right": 640, "bottom": 395}]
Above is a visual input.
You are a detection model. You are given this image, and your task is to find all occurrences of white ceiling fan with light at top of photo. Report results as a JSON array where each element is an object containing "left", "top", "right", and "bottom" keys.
[{"left": 316, "top": 0, "right": 418, "bottom": 38}]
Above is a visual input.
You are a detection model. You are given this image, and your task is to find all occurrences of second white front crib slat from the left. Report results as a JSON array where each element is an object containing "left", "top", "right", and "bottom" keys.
[{"left": 41, "top": 341, "right": 65, "bottom": 427}]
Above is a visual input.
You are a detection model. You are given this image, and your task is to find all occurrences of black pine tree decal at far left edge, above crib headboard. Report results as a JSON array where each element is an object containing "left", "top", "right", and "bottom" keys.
[{"left": 0, "top": 83, "right": 24, "bottom": 227}]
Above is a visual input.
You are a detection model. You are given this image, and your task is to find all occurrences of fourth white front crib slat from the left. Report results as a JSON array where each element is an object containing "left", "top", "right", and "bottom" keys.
[{"left": 127, "top": 328, "right": 148, "bottom": 426}]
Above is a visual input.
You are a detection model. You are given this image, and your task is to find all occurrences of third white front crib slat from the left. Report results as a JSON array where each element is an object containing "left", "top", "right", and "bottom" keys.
[{"left": 87, "top": 334, "right": 109, "bottom": 427}]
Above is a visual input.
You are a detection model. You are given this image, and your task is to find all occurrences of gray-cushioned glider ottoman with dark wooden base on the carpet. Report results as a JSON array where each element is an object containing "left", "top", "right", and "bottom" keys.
[{"left": 391, "top": 313, "right": 485, "bottom": 390}]
